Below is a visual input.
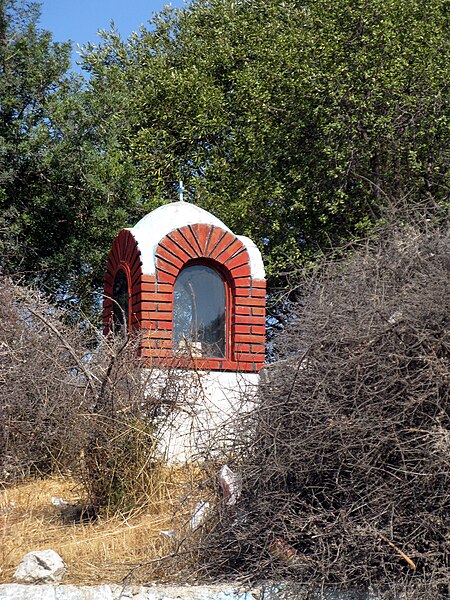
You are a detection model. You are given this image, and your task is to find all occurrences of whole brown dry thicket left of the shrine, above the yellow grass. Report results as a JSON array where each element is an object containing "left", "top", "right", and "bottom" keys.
[{"left": 0, "top": 279, "right": 189, "bottom": 510}]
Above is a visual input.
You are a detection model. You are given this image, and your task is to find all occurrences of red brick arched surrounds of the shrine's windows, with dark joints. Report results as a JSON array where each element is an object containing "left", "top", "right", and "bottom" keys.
[{"left": 104, "top": 224, "right": 266, "bottom": 372}]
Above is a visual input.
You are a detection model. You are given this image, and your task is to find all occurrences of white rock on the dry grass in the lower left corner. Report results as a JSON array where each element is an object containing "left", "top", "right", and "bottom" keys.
[{"left": 13, "top": 550, "right": 66, "bottom": 583}]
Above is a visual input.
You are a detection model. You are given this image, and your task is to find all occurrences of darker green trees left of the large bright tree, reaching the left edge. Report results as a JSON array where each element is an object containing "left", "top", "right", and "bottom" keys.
[{"left": 0, "top": 0, "right": 137, "bottom": 313}]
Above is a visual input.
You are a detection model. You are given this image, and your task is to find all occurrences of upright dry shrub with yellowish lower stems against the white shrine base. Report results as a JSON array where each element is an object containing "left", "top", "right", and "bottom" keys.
[{"left": 81, "top": 334, "right": 191, "bottom": 511}]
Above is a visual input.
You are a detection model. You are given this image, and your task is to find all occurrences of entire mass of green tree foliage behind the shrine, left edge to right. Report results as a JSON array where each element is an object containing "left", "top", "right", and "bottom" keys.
[{"left": 0, "top": 0, "right": 450, "bottom": 316}]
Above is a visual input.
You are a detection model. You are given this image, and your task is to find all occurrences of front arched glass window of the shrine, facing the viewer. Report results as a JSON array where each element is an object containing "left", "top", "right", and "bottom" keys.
[{"left": 173, "top": 264, "right": 226, "bottom": 358}]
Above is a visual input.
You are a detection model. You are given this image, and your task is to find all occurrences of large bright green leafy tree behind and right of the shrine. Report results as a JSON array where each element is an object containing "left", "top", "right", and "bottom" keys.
[{"left": 85, "top": 0, "right": 450, "bottom": 296}]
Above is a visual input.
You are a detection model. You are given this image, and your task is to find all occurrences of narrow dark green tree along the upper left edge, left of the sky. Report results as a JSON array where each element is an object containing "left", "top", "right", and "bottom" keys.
[{"left": 0, "top": 0, "right": 70, "bottom": 267}]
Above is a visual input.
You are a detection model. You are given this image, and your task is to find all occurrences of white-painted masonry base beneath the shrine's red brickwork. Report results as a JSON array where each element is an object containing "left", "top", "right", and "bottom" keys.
[{"left": 148, "top": 369, "right": 259, "bottom": 464}]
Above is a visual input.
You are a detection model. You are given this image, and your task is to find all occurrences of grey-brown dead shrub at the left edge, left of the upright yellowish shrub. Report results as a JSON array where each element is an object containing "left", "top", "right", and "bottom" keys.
[{"left": 0, "top": 279, "right": 86, "bottom": 482}]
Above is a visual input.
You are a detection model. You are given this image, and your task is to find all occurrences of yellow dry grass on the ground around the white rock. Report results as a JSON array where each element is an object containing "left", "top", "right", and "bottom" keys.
[{"left": 0, "top": 467, "right": 198, "bottom": 584}]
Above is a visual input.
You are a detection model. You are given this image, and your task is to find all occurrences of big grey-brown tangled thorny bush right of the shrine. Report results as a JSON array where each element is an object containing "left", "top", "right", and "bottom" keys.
[{"left": 199, "top": 228, "right": 450, "bottom": 599}]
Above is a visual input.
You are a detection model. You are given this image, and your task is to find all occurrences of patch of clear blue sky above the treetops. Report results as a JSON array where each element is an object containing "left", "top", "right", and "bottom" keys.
[{"left": 40, "top": 0, "right": 184, "bottom": 68}]
